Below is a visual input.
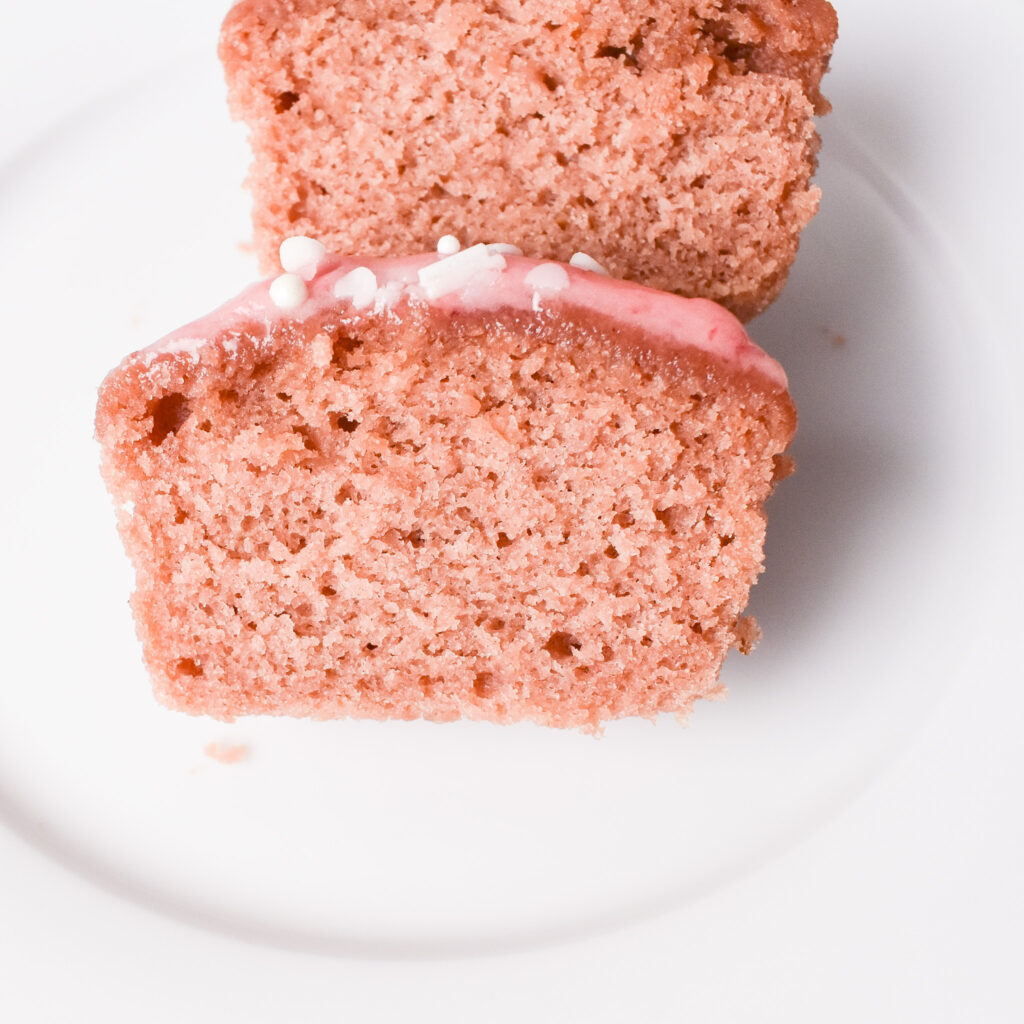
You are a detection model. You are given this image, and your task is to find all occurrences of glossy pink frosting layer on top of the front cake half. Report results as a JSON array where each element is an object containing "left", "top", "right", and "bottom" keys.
[{"left": 138, "top": 253, "right": 786, "bottom": 388}]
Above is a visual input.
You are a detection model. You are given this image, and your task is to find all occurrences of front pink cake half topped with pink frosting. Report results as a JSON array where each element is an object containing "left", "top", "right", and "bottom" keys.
[{"left": 96, "top": 251, "right": 796, "bottom": 729}]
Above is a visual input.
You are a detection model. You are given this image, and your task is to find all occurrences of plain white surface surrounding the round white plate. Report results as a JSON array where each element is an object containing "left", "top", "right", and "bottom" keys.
[{"left": 0, "top": 0, "right": 1024, "bottom": 1022}]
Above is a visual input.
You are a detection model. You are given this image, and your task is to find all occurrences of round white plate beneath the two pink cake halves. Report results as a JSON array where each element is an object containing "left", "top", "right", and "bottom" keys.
[{"left": 0, "top": 4, "right": 1024, "bottom": 1021}]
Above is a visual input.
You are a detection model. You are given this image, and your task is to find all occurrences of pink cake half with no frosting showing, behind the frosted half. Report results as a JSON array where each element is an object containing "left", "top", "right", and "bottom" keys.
[{"left": 220, "top": 0, "right": 837, "bottom": 319}]
